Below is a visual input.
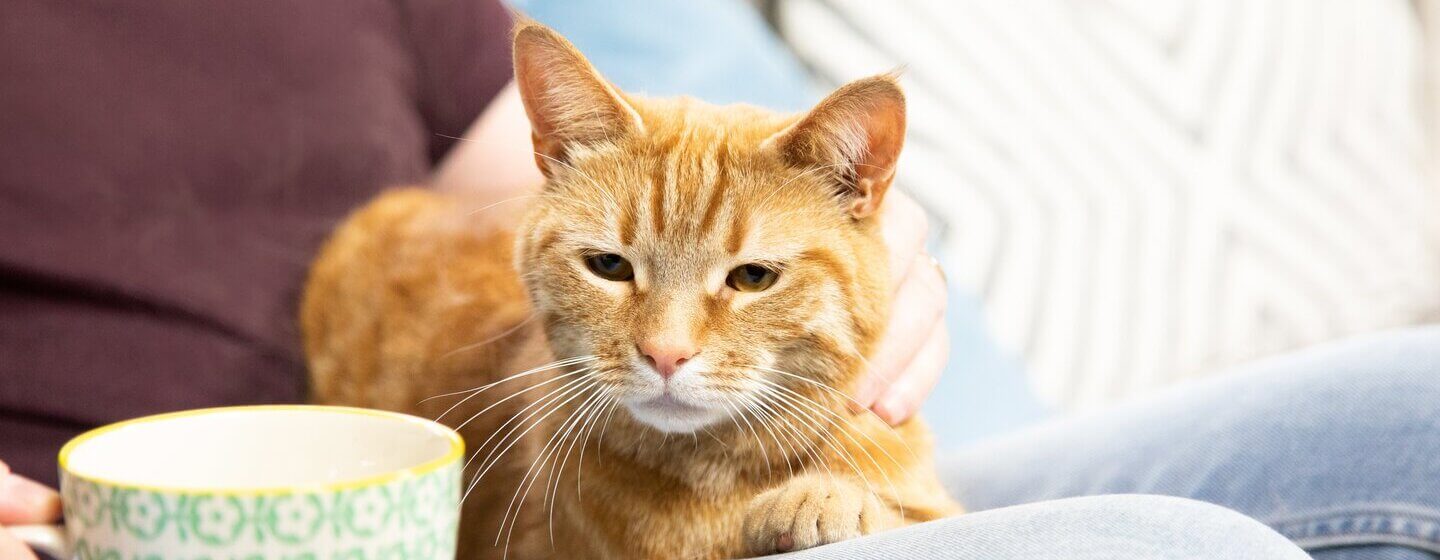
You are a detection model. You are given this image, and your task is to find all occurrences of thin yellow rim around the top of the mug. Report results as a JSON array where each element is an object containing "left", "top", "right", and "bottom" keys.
[{"left": 60, "top": 405, "right": 465, "bottom": 495}]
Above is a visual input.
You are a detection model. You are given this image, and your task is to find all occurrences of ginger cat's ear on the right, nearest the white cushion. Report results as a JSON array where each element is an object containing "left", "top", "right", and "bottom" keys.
[{"left": 762, "top": 75, "right": 904, "bottom": 217}]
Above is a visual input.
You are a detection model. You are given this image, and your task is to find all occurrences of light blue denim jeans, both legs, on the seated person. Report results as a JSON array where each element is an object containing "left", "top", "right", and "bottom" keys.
[{"left": 796, "top": 325, "right": 1440, "bottom": 560}]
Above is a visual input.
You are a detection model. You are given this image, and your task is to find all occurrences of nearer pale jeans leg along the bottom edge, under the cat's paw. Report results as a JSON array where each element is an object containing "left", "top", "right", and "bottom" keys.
[{"left": 782, "top": 495, "right": 1308, "bottom": 560}]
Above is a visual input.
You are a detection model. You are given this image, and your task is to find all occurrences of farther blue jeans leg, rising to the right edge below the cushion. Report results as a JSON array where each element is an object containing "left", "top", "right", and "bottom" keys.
[{"left": 943, "top": 325, "right": 1440, "bottom": 560}]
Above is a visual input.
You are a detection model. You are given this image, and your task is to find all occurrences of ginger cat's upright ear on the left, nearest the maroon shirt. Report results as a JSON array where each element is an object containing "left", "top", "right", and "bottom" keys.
[{"left": 514, "top": 22, "right": 644, "bottom": 177}]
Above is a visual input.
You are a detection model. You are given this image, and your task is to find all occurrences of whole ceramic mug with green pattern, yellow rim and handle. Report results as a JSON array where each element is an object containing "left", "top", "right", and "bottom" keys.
[{"left": 10, "top": 406, "right": 464, "bottom": 560}]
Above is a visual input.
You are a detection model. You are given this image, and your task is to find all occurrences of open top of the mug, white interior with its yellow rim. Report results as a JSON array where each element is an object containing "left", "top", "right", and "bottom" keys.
[{"left": 60, "top": 406, "right": 462, "bottom": 491}]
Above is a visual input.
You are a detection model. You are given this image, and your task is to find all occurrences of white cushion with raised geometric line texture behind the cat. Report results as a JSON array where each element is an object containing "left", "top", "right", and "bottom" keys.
[{"left": 779, "top": 0, "right": 1440, "bottom": 409}]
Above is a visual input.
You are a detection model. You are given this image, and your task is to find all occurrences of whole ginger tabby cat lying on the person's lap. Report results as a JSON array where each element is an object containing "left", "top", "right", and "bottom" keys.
[{"left": 301, "top": 23, "right": 959, "bottom": 559}]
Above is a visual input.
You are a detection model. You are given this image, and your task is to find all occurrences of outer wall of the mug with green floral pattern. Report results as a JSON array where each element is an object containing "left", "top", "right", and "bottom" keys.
[{"left": 62, "top": 461, "right": 459, "bottom": 560}]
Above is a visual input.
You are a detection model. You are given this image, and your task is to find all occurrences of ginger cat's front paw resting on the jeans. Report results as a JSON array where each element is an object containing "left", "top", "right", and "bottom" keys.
[{"left": 743, "top": 475, "right": 899, "bottom": 554}]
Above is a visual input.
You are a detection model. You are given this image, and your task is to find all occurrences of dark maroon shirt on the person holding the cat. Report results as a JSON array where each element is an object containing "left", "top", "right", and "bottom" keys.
[{"left": 0, "top": 0, "right": 510, "bottom": 482}]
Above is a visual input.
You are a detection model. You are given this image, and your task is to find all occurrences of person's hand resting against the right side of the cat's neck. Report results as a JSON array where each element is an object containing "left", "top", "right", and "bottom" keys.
[{"left": 855, "top": 189, "right": 950, "bottom": 425}]
